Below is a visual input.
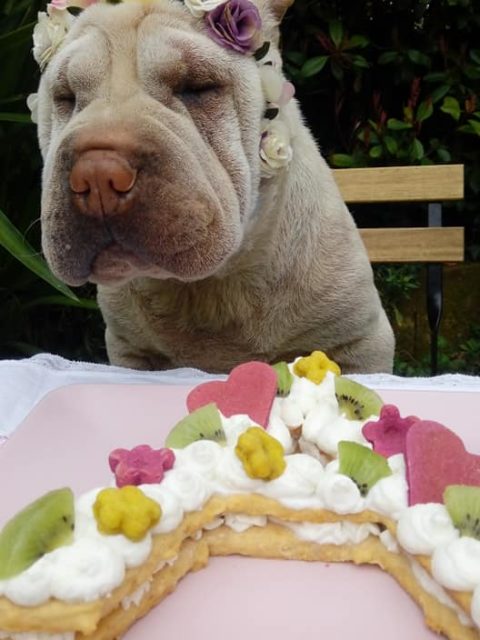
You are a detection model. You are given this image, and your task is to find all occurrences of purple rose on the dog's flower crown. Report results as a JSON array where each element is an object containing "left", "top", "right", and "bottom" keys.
[{"left": 207, "top": 0, "right": 262, "bottom": 53}]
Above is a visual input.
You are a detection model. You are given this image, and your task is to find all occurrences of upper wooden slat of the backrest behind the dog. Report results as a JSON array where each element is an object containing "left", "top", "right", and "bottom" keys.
[{"left": 333, "top": 164, "right": 463, "bottom": 203}]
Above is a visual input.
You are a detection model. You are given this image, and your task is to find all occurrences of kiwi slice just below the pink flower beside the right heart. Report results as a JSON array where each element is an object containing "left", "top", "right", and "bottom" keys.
[{"left": 338, "top": 440, "right": 392, "bottom": 496}]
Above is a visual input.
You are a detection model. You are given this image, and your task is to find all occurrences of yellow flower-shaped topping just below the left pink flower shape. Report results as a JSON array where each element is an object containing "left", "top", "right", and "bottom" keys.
[{"left": 93, "top": 485, "right": 162, "bottom": 542}]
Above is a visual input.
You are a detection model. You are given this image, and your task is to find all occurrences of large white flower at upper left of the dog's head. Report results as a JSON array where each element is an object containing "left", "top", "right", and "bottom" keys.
[{"left": 33, "top": 5, "right": 74, "bottom": 71}]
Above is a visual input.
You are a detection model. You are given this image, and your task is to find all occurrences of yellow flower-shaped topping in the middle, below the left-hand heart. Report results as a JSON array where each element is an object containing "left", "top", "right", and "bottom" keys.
[{"left": 235, "top": 427, "right": 287, "bottom": 480}]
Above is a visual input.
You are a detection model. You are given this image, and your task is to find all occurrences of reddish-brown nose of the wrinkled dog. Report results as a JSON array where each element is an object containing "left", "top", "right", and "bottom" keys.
[{"left": 70, "top": 149, "right": 137, "bottom": 216}]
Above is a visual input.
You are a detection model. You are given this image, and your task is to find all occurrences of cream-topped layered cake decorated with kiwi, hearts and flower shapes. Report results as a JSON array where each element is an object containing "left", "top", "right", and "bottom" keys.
[{"left": 0, "top": 352, "right": 480, "bottom": 640}]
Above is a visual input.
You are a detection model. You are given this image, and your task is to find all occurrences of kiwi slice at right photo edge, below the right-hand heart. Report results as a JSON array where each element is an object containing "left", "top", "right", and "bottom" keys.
[{"left": 443, "top": 484, "right": 480, "bottom": 540}]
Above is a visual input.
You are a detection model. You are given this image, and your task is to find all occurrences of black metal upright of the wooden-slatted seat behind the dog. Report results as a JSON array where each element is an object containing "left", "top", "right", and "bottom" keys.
[{"left": 427, "top": 203, "right": 443, "bottom": 376}]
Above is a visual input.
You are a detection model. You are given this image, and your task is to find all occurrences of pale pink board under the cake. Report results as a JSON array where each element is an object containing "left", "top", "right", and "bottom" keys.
[{"left": 0, "top": 385, "right": 480, "bottom": 640}]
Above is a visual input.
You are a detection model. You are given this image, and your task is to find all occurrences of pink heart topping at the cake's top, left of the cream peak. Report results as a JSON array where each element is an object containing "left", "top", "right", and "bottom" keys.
[{"left": 187, "top": 362, "right": 277, "bottom": 428}]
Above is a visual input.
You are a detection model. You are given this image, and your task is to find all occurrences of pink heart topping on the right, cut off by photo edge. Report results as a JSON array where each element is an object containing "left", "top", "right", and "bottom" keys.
[{"left": 406, "top": 420, "right": 480, "bottom": 506}]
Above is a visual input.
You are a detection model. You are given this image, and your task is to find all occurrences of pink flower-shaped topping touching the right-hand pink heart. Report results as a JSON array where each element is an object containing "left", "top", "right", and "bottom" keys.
[{"left": 362, "top": 404, "right": 418, "bottom": 458}]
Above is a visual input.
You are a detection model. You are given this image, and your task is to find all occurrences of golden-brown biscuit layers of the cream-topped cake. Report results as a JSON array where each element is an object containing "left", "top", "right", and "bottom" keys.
[{"left": 0, "top": 494, "right": 480, "bottom": 640}]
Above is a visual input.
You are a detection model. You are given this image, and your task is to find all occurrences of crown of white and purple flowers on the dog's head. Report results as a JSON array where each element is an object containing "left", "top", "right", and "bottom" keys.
[{"left": 31, "top": 0, "right": 295, "bottom": 177}]
